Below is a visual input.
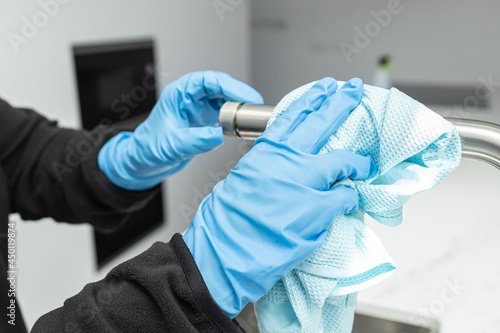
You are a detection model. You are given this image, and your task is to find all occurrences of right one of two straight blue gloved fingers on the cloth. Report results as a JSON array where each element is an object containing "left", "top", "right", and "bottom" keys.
[{"left": 289, "top": 78, "right": 363, "bottom": 154}]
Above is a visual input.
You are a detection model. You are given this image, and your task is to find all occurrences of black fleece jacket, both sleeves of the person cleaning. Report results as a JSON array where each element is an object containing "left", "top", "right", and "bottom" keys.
[{"left": 0, "top": 99, "right": 242, "bottom": 333}]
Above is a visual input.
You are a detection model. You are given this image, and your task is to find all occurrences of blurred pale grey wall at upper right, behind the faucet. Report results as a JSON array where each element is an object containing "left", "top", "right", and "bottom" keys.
[{"left": 252, "top": 0, "right": 500, "bottom": 119}]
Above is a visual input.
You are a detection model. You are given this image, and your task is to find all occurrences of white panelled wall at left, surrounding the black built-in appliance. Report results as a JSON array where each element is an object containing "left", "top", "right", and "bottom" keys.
[{"left": 0, "top": 0, "right": 249, "bottom": 326}]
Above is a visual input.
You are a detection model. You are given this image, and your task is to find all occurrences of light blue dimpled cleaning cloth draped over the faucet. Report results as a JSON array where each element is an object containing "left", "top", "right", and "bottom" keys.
[{"left": 255, "top": 82, "right": 461, "bottom": 333}]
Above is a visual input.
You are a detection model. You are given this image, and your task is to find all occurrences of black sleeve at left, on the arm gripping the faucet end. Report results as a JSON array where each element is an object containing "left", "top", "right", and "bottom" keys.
[{"left": 0, "top": 99, "right": 159, "bottom": 231}]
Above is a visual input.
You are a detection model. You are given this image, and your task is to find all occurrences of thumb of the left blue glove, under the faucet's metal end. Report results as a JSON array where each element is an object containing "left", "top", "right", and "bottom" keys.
[{"left": 176, "top": 126, "right": 223, "bottom": 157}]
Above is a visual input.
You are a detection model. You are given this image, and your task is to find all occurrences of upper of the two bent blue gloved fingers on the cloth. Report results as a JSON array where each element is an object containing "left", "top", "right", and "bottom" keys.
[{"left": 313, "top": 149, "right": 378, "bottom": 189}]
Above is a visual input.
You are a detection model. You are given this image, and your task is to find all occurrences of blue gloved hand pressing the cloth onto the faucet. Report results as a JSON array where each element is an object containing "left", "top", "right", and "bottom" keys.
[{"left": 184, "top": 78, "right": 377, "bottom": 318}]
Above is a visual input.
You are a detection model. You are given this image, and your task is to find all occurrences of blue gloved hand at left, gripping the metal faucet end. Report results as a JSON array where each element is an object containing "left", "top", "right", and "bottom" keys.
[{"left": 98, "top": 71, "right": 263, "bottom": 190}]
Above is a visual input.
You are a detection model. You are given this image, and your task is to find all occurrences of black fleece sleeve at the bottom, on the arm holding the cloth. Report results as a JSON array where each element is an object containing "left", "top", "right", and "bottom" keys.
[{"left": 31, "top": 234, "right": 243, "bottom": 333}]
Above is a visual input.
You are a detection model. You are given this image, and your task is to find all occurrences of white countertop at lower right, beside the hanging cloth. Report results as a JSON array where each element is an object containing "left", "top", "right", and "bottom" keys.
[{"left": 358, "top": 160, "right": 500, "bottom": 333}]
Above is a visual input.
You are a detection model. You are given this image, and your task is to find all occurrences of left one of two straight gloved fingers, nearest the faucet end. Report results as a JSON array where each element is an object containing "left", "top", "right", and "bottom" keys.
[{"left": 263, "top": 77, "right": 337, "bottom": 138}]
